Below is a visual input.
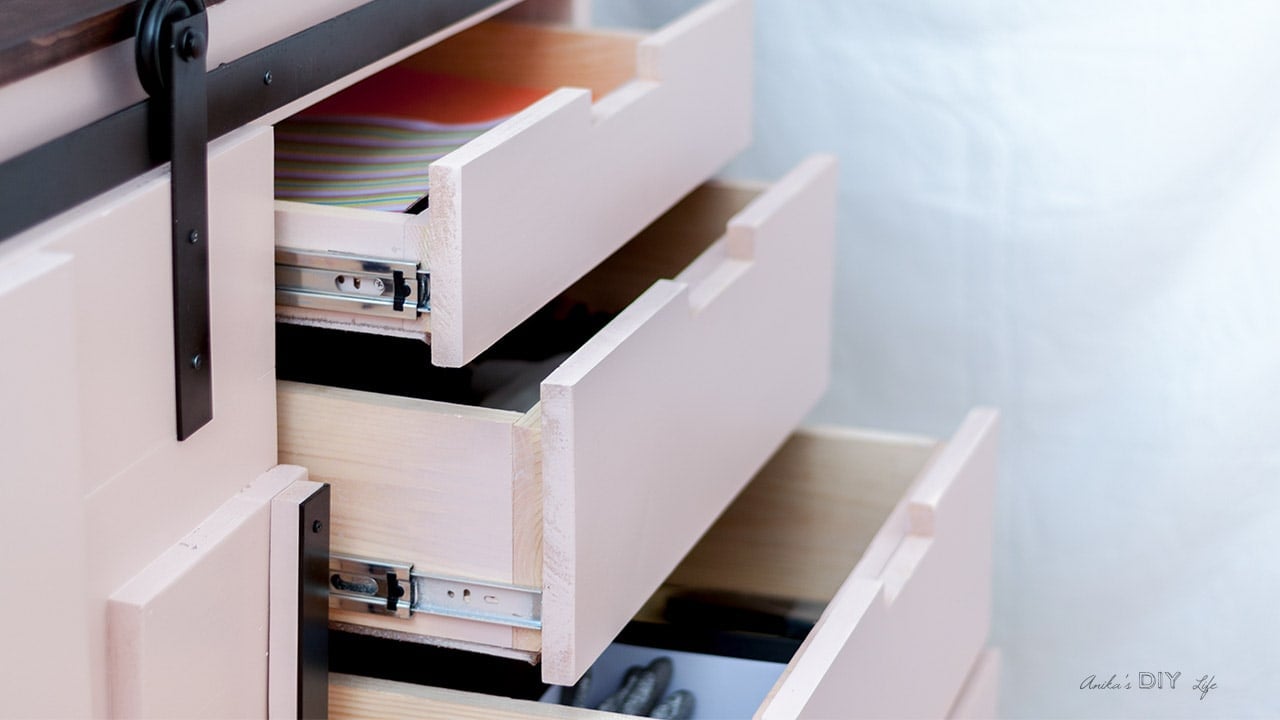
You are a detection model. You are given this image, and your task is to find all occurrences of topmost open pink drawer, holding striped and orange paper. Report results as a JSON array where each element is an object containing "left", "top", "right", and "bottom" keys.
[{"left": 276, "top": 0, "right": 751, "bottom": 366}]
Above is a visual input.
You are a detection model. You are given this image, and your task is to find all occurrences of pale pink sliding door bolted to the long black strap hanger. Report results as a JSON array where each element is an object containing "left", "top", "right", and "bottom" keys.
[{"left": 0, "top": 122, "right": 275, "bottom": 716}]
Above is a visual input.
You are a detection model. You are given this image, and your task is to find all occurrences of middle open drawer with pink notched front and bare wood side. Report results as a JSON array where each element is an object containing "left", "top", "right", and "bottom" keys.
[{"left": 279, "top": 158, "right": 836, "bottom": 683}]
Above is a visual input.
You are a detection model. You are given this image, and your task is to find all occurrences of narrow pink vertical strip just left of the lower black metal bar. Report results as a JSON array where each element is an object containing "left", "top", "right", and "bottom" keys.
[{"left": 266, "top": 465, "right": 324, "bottom": 717}]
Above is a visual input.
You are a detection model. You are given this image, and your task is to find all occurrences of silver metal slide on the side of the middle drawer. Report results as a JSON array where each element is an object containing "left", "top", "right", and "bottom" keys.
[{"left": 329, "top": 555, "right": 543, "bottom": 630}]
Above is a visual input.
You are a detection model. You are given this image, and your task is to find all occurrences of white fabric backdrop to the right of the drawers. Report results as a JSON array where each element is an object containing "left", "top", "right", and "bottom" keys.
[{"left": 598, "top": 0, "right": 1280, "bottom": 717}]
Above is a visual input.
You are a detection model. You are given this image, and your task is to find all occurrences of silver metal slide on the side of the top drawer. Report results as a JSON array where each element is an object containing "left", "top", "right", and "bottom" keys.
[{"left": 275, "top": 247, "right": 430, "bottom": 318}]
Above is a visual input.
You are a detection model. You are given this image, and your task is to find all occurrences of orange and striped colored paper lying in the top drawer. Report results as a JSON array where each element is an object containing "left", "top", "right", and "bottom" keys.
[{"left": 275, "top": 67, "right": 547, "bottom": 213}]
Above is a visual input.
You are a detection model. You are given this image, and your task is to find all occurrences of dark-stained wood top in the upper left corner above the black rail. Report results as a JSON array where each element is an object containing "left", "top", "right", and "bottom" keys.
[{"left": 0, "top": 0, "right": 221, "bottom": 85}]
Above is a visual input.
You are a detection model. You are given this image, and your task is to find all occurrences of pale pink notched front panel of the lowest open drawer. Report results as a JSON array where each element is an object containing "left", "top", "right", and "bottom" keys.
[{"left": 758, "top": 409, "right": 997, "bottom": 717}]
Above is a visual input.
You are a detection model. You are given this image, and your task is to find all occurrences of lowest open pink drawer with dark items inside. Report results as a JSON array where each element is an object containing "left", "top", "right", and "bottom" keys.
[{"left": 322, "top": 409, "right": 997, "bottom": 719}]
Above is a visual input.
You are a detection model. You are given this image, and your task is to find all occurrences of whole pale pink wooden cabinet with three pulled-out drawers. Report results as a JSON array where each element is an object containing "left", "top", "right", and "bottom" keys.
[{"left": 0, "top": 0, "right": 996, "bottom": 717}]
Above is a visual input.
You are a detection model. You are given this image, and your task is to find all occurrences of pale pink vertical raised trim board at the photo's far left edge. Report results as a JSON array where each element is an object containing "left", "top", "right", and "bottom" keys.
[{"left": 0, "top": 246, "right": 92, "bottom": 717}]
